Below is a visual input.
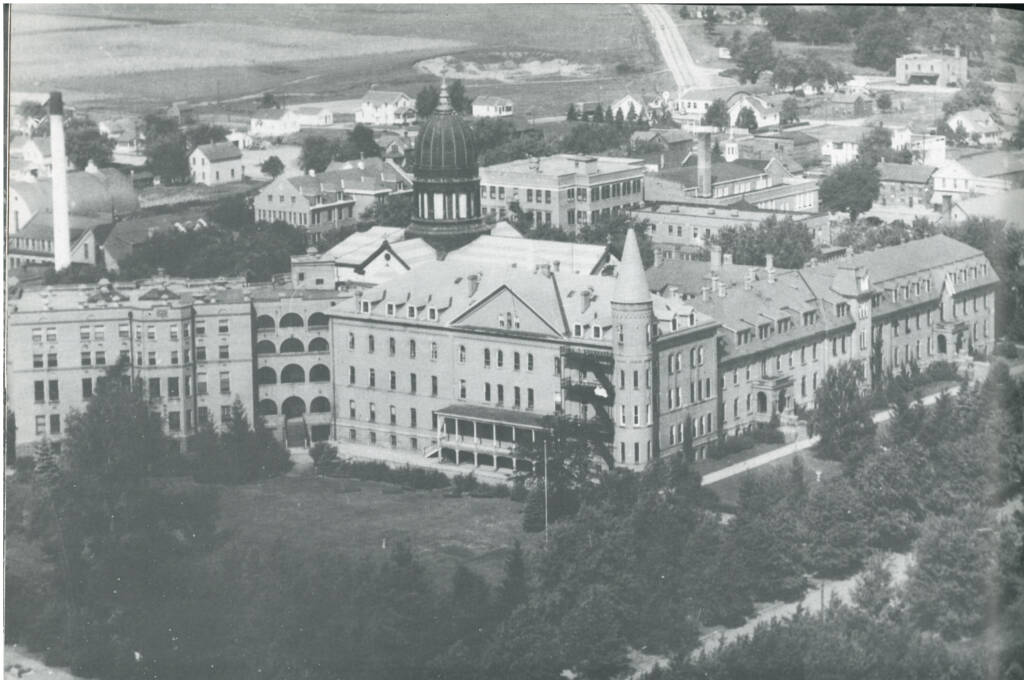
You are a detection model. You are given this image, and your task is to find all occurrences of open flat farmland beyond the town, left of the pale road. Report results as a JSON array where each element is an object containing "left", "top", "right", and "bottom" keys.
[{"left": 11, "top": 5, "right": 668, "bottom": 115}]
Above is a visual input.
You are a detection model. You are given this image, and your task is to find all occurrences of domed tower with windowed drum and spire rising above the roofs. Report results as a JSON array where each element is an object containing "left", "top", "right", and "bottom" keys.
[{"left": 408, "top": 80, "right": 490, "bottom": 252}]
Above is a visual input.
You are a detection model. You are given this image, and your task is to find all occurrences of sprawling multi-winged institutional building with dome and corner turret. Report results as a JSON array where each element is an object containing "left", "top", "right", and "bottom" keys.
[{"left": 7, "top": 80, "right": 997, "bottom": 469}]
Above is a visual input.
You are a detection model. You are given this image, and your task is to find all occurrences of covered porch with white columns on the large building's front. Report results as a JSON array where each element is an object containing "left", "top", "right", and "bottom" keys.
[{"left": 426, "top": 403, "right": 548, "bottom": 472}]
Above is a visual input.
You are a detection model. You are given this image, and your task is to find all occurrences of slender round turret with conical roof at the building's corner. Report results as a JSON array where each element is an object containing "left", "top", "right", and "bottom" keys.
[{"left": 611, "top": 229, "right": 657, "bottom": 468}]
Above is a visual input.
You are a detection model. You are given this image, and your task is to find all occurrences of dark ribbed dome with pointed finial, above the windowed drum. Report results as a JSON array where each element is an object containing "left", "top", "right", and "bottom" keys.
[{"left": 413, "top": 83, "right": 477, "bottom": 178}]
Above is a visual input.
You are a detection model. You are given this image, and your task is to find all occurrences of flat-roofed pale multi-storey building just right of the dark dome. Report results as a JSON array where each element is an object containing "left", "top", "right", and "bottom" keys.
[{"left": 480, "top": 154, "right": 644, "bottom": 231}]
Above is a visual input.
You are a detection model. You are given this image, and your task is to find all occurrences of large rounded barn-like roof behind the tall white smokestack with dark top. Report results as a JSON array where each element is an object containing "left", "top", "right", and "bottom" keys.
[{"left": 10, "top": 168, "right": 138, "bottom": 215}]
